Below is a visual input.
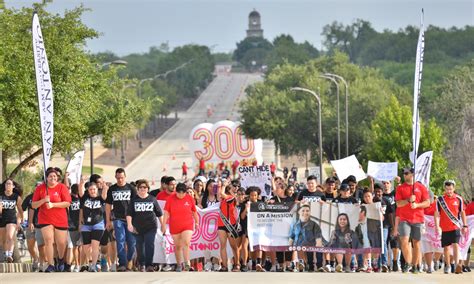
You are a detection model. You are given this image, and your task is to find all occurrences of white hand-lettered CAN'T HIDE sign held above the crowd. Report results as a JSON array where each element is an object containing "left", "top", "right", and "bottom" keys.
[{"left": 239, "top": 165, "right": 272, "bottom": 196}]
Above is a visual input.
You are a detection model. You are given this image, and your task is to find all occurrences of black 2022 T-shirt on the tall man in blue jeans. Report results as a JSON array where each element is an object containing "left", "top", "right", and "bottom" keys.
[{"left": 105, "top": 183, "right": 137, "bottom": 220}]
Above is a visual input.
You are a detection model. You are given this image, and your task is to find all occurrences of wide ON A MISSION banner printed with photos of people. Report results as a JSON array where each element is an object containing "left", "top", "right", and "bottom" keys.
[{"left": 248, "top": 202, "right": 382, "bottom": 253}]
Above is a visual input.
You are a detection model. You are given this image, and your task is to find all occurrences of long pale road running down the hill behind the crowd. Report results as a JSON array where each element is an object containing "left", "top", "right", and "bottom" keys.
[{"left": 124, "top": 68, "right": 274, "bottom": 180}]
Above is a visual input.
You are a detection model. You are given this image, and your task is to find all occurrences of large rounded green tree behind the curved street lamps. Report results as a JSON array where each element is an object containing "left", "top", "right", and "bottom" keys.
[{"left": 241, "top": 52, "right": 409, "bottom": 160}]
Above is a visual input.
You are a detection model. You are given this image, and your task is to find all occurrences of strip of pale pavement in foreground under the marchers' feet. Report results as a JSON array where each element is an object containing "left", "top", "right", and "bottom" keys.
[{"left": 0, "top": 272, "right": 474, "bottom": 284}]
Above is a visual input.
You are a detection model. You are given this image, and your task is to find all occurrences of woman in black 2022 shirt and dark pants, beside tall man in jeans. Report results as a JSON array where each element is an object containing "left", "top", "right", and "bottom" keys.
[{"left": 127, "top": 179, "right": 164, "bottom": 272}]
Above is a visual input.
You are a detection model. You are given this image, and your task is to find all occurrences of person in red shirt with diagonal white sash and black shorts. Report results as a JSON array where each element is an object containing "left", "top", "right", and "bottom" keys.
[{"left": 435, "top": 180, "right": 468, "bottom": 274}]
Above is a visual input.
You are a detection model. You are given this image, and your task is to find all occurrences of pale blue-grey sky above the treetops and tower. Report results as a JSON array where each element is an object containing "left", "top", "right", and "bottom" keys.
[{"left": 5, "top": 0, "right": 474, "bottom": 56}]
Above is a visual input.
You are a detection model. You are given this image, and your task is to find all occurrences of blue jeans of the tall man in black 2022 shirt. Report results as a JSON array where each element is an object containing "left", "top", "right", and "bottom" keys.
[{"left": 113, "top": 220, "right": 135, "bottom": 266}]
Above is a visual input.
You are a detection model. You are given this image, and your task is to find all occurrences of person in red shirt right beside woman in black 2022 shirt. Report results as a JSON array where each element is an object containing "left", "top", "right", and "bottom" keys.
[{"left": 161, "top": 183, "right": 199, "bottom": 272}]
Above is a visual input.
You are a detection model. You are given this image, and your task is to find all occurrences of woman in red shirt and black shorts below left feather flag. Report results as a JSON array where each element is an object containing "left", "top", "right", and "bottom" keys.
[{"left": 31, "top": 168, "right": 71, "bottom": 272}]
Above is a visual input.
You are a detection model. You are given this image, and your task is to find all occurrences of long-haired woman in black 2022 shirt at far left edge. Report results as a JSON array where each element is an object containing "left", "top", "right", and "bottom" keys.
[{"left": 0, "top": 179, "right": 23, "bottom": 262}]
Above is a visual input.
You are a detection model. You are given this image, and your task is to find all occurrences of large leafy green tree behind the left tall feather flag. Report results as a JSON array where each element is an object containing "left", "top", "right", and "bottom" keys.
[{"left": 0, "top": 5, "right": 147, "bottom": 177}]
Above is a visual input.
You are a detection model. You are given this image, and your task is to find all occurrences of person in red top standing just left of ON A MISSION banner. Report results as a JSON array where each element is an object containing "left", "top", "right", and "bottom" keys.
[{"left": 217, "top": 183, "right": 240, "bottom": 272}]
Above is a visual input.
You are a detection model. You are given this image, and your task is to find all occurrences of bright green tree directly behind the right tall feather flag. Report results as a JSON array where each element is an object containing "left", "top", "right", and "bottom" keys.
[{"left": 361, "top": 96, "right": 450, "bottom": 194}]
